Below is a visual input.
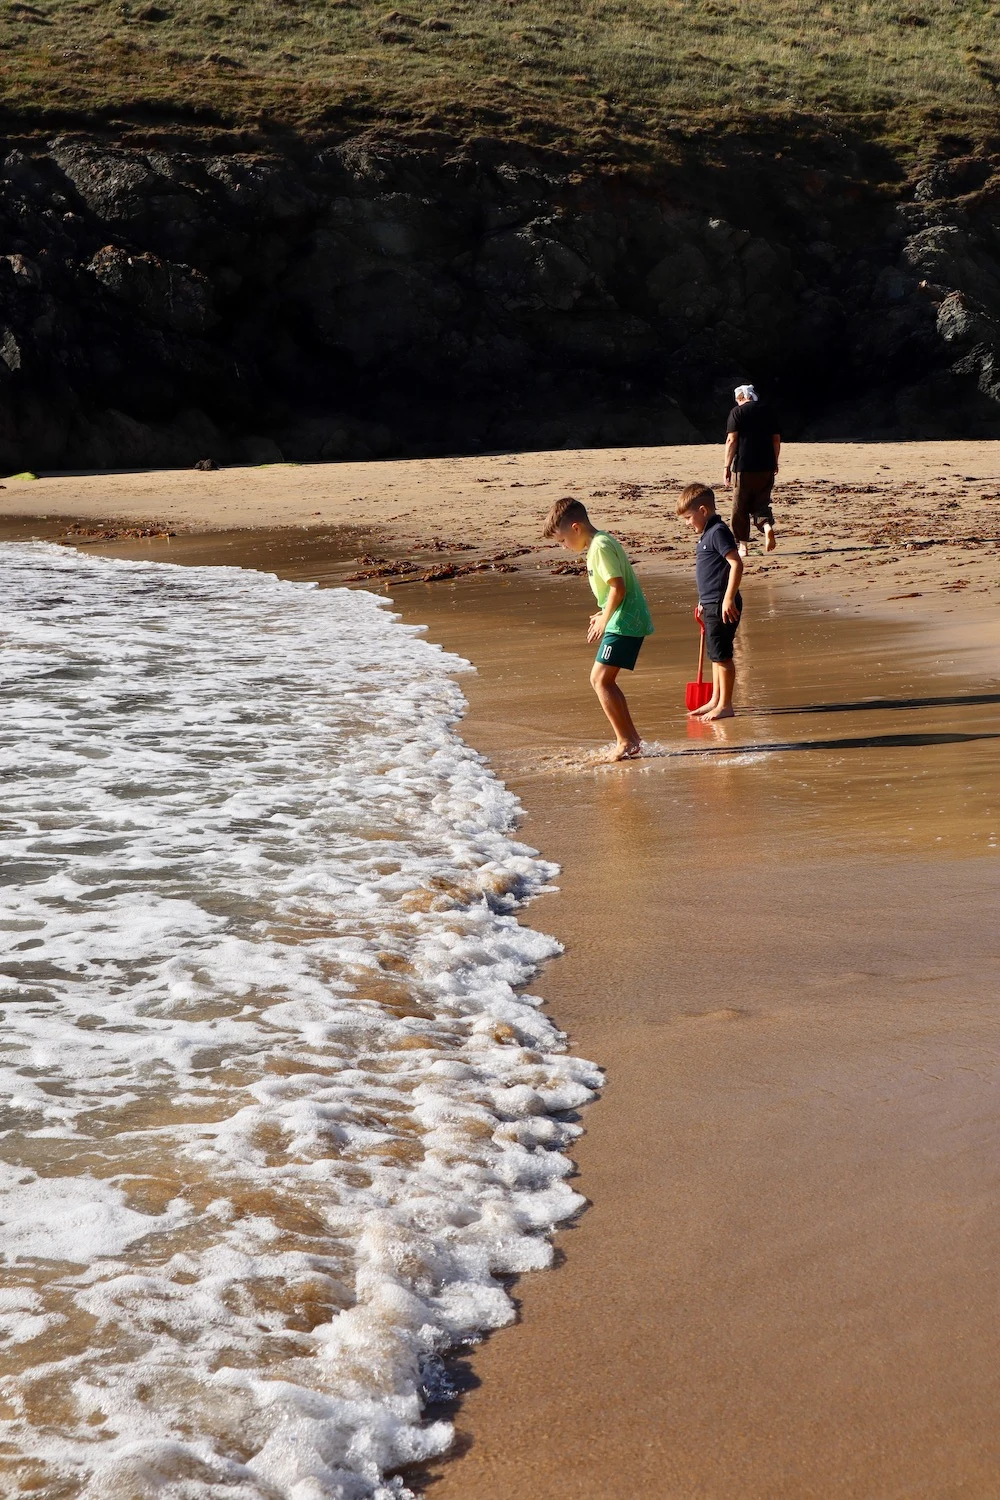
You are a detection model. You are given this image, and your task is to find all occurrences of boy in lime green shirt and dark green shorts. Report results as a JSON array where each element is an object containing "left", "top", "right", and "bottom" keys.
[{"left": 543, "top": 495, "right": 652, "bottom": 761}]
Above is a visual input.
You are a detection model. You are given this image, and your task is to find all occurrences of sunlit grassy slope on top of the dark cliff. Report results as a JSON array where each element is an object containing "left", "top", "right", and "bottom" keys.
[{"left": 0, "top": 0, "right": 1000, "bottom": 155}]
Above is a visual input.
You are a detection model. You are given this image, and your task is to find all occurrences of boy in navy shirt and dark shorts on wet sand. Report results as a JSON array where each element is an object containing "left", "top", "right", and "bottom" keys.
[{"left": 678, "top": 485, "right": 744, "bottom": 720}]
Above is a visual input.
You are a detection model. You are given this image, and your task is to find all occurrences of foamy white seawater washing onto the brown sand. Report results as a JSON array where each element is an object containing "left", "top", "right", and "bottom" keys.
[{"left": 0, "top": 545, "right": 600, "bottom": 1500}]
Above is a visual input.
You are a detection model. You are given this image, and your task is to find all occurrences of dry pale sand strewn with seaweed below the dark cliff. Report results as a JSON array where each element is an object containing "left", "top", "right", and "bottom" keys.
[{"left": 0, "top": 443, "right": 1000, "bottom": 617}]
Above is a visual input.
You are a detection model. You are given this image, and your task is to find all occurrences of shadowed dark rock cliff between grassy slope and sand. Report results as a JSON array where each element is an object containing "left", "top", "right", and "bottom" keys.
[{"left": 0, "top": 137, "right": 1000, "bottom": 470}]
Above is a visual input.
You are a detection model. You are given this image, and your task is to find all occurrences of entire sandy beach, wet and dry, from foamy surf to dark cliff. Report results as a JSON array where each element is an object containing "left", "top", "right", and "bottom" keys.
[{"left": 4, "top": 444, "right": 1000, "bottom": 1500}]
